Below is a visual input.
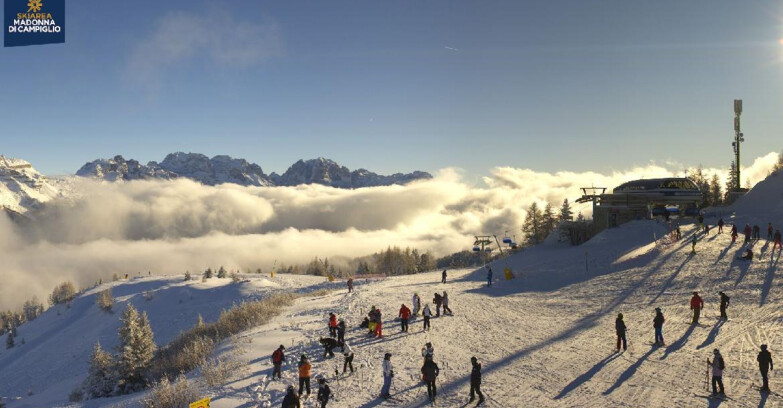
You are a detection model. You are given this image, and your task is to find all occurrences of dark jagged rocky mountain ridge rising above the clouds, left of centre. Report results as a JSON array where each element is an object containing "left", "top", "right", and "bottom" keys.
[{"left": 76, "top": 152, "right": 432, "bottom": 188}]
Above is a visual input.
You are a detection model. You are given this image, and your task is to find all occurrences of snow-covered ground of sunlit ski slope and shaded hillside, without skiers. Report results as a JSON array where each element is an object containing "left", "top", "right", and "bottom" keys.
[{"left": 0, "top": 173, "right": 783, "bottom": 408}]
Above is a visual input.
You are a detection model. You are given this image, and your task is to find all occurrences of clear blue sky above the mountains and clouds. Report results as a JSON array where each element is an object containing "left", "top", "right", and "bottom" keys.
[{"left": 0, "top": 0, "right": 783, "bottom": 177}]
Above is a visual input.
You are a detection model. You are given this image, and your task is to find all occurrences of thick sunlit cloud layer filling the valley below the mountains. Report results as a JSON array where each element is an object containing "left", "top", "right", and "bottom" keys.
[{"left": 0, "top": 153, "right": 777, "bottom": 309}]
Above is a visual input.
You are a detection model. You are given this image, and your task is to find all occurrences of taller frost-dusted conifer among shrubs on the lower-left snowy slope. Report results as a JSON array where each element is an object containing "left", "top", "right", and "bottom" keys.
[{"left": 119, "top": 303, "right": 156, "bottom": 392}]
